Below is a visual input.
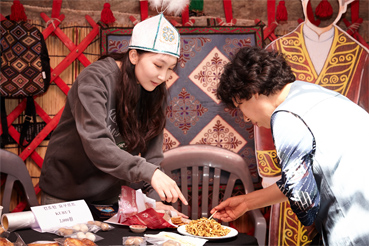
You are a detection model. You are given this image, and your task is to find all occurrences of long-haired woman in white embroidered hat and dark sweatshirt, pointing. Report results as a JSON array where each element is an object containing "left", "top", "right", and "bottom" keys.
[{"left": 40, "top": 15, "right": 187, "bottom": 213}]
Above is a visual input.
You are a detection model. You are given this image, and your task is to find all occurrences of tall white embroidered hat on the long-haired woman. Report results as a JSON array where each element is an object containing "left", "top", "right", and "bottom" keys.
[{"left": 128, "top": 14, "right": 180, "bottom": 58}]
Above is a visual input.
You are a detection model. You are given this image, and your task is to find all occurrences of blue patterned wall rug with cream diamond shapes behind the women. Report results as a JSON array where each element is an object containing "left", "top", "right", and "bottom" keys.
[{"left": 100, "top": 25, "right": 263, "bottom": 184}]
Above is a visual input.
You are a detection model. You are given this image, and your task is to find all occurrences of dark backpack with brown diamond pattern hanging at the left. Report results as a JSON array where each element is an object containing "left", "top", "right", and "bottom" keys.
[{"left": 0, "top": 19, "right": 48, "bottom": 98}]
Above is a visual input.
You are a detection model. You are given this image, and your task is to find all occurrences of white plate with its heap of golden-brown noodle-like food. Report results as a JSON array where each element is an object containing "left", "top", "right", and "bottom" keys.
[{"left": 177, "top": 218, "right": 238, "bottom": 240}]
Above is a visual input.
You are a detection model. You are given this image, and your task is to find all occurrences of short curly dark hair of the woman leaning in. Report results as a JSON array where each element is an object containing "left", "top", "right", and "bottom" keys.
[{"left": 216, "top": 47, "right": 296, "bottom": 108}]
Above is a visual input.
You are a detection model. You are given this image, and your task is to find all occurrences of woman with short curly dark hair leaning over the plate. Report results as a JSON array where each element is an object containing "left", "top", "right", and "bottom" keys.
[{"left": 211, "top": 47, "right": 369, "bottom": 245}]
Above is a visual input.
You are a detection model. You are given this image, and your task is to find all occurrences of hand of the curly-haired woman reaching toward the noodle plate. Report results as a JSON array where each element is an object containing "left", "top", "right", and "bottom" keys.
[{"left": 210, "top": 195, "right": 247, "bottom": 222}]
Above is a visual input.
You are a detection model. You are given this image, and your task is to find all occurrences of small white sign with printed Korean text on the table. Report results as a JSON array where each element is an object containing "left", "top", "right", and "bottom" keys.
[{"left": 31, "top": 200, "right": 94, "bottom": 232}]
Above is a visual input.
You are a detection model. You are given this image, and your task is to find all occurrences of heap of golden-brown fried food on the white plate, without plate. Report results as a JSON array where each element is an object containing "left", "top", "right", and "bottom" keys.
[{"left": 186, "top": 217, "right": 231, "bottom": 237}]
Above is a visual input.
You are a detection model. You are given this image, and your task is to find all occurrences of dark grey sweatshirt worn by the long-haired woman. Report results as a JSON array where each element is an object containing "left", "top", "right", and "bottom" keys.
[{"left": 39, "top": 58, "right": 163, "bottom": 202}]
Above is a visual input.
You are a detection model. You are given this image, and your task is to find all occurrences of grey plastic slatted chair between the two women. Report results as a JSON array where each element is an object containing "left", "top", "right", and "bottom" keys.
[{"left": 161, "top": 145, "right": 266, "bottom": 245}]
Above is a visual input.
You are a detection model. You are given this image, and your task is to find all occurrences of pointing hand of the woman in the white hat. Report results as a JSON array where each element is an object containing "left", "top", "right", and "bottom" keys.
[{"left": 151, "top": 169, "right": 188, "bottom": 205}]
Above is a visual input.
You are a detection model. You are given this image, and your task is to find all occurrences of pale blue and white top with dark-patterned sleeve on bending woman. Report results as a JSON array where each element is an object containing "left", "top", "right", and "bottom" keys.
[{"left": 271, "top": 81, "right": 369, "bottom": 245}]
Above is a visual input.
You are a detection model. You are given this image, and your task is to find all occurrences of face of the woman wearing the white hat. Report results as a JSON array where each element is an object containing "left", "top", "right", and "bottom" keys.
[{"left": 129, "top": 50, "right": 177, "bottom": 91}]
